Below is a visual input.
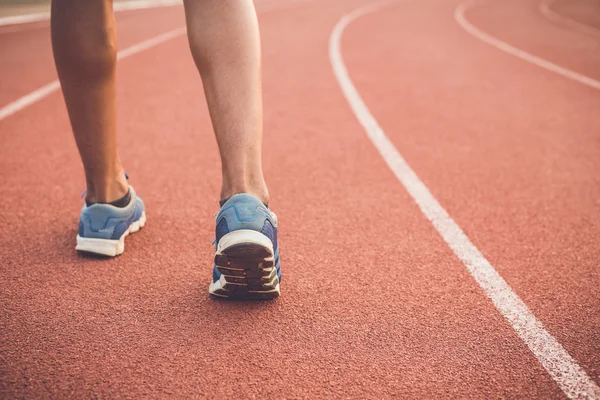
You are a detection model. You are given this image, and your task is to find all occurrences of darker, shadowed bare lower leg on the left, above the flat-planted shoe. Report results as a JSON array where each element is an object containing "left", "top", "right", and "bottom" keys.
[{"left": 51, "top": 0, "right": 128, "bottom": 202}]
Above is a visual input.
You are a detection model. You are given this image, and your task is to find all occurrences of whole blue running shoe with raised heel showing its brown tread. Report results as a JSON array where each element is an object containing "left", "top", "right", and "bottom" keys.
[{"left": 208, "top": 194, "right": 281, "bottom": 299}]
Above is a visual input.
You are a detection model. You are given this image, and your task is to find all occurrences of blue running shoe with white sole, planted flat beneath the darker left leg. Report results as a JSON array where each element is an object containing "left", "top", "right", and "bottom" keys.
[{"left": 75, "top": 186, "right": 146, "bottom": 257}]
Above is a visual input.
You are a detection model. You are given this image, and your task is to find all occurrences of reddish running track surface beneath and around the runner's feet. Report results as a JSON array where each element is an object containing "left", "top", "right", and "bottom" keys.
[{"left": 0, "top": 0, "right": 600, "bottom": 399}]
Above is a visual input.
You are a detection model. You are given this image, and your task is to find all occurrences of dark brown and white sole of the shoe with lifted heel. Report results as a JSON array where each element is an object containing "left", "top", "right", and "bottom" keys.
[{"left": 208, "top": 229, "right": 280, "bottom": 299}]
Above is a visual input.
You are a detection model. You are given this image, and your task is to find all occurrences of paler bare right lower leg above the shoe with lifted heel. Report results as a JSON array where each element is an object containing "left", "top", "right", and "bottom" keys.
[{"left": 184, "top": 0, "right": 269, "bottom": 203}]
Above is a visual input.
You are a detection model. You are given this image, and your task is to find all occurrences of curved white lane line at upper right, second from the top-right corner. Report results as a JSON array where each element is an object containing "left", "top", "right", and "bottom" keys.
[{"left": 454, "top": 0, "right": 600, "bottom": 90}]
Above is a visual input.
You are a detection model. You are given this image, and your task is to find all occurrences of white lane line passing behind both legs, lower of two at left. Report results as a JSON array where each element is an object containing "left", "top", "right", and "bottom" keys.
[{"left": 0, "top": 0, "right": 314, "bottom": 121}]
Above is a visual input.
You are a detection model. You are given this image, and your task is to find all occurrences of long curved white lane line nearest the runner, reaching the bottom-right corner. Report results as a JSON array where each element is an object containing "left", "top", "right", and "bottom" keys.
[{"left": 329, "top": 1, "right": 600, "bottom": 399}]
